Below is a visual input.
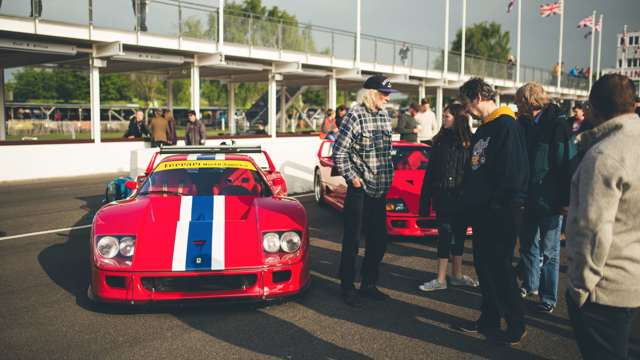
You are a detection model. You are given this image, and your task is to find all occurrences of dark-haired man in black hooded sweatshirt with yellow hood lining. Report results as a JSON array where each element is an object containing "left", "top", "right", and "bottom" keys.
[{"left": 459, "top": 78, "right": 529, "bottom": 345}]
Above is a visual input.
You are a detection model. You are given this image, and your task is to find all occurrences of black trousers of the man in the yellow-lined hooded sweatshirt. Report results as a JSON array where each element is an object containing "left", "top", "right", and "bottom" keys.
[{"left": 473, "top": 207, "right": 525, "bottom": 332}]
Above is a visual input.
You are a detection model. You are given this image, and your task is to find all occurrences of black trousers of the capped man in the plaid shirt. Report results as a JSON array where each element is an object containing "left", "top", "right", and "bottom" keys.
[{"left": 340, "top": 185, "right": 387, "bottom": 290}]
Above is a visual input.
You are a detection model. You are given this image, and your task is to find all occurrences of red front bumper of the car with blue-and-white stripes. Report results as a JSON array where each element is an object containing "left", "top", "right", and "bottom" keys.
[{"left": 91, "top": 261, "right": 310, "bottom": 304}]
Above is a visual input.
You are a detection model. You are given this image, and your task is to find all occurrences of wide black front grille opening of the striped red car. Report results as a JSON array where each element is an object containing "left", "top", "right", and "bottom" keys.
[{"left": 141, "top": 274, "right": 258, "bottom": 292}]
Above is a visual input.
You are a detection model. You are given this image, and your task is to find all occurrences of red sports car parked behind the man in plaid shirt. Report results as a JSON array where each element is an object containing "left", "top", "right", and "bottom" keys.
[{"left": 314, "top": 140, "right": 438, "bottom": 236}]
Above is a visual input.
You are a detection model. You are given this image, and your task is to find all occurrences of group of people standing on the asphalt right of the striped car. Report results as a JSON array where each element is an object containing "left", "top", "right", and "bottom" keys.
[{"left": 328, "top": 74, "right": 640, "bottom": 359}]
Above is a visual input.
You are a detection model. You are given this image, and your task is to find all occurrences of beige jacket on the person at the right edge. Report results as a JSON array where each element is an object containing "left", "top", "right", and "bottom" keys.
[{"left": 567, "top": 113, "right": 640, "bottom": 307}]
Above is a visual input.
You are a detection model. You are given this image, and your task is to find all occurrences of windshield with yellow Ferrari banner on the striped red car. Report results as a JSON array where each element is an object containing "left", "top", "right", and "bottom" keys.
[{"left": 140, "top": 160, "right": 271, "bottom": 196}]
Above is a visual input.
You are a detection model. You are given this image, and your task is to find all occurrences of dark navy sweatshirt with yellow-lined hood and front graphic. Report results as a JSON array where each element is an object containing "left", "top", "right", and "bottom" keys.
[{"left": 463, "top": 106, "right": 529, "bottom": 208}]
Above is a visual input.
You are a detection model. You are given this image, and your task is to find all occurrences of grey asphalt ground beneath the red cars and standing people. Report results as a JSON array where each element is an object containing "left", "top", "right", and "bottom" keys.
[{"left": 0, "top": 174, "right": 639, "bottom": 359}]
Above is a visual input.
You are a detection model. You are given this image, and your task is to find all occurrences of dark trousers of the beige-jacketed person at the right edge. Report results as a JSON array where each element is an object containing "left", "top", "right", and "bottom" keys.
[{"left": 566, "top": 293, "right": 638, "bottom": 360}]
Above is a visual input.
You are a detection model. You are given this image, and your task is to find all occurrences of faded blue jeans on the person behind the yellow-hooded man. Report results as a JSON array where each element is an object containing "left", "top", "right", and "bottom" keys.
[{"left": 520, "top": 214, "right": 562, "bottom": 306}]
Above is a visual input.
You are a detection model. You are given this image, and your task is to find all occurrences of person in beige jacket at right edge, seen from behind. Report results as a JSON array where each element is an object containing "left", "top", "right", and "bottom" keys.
[{"left": 566, "top": 74, "right": 640, "bottom": 359}]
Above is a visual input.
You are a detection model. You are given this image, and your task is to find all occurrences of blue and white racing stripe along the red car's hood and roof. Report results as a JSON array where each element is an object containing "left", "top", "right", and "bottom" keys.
[{"left": 172, "top": 154, "right": 225, "bottom": 271}]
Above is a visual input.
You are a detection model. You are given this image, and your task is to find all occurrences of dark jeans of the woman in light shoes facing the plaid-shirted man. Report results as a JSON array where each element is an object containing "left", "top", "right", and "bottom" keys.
[{"left": 436, "top": 212, "right": 468, "bottom": 259}]
